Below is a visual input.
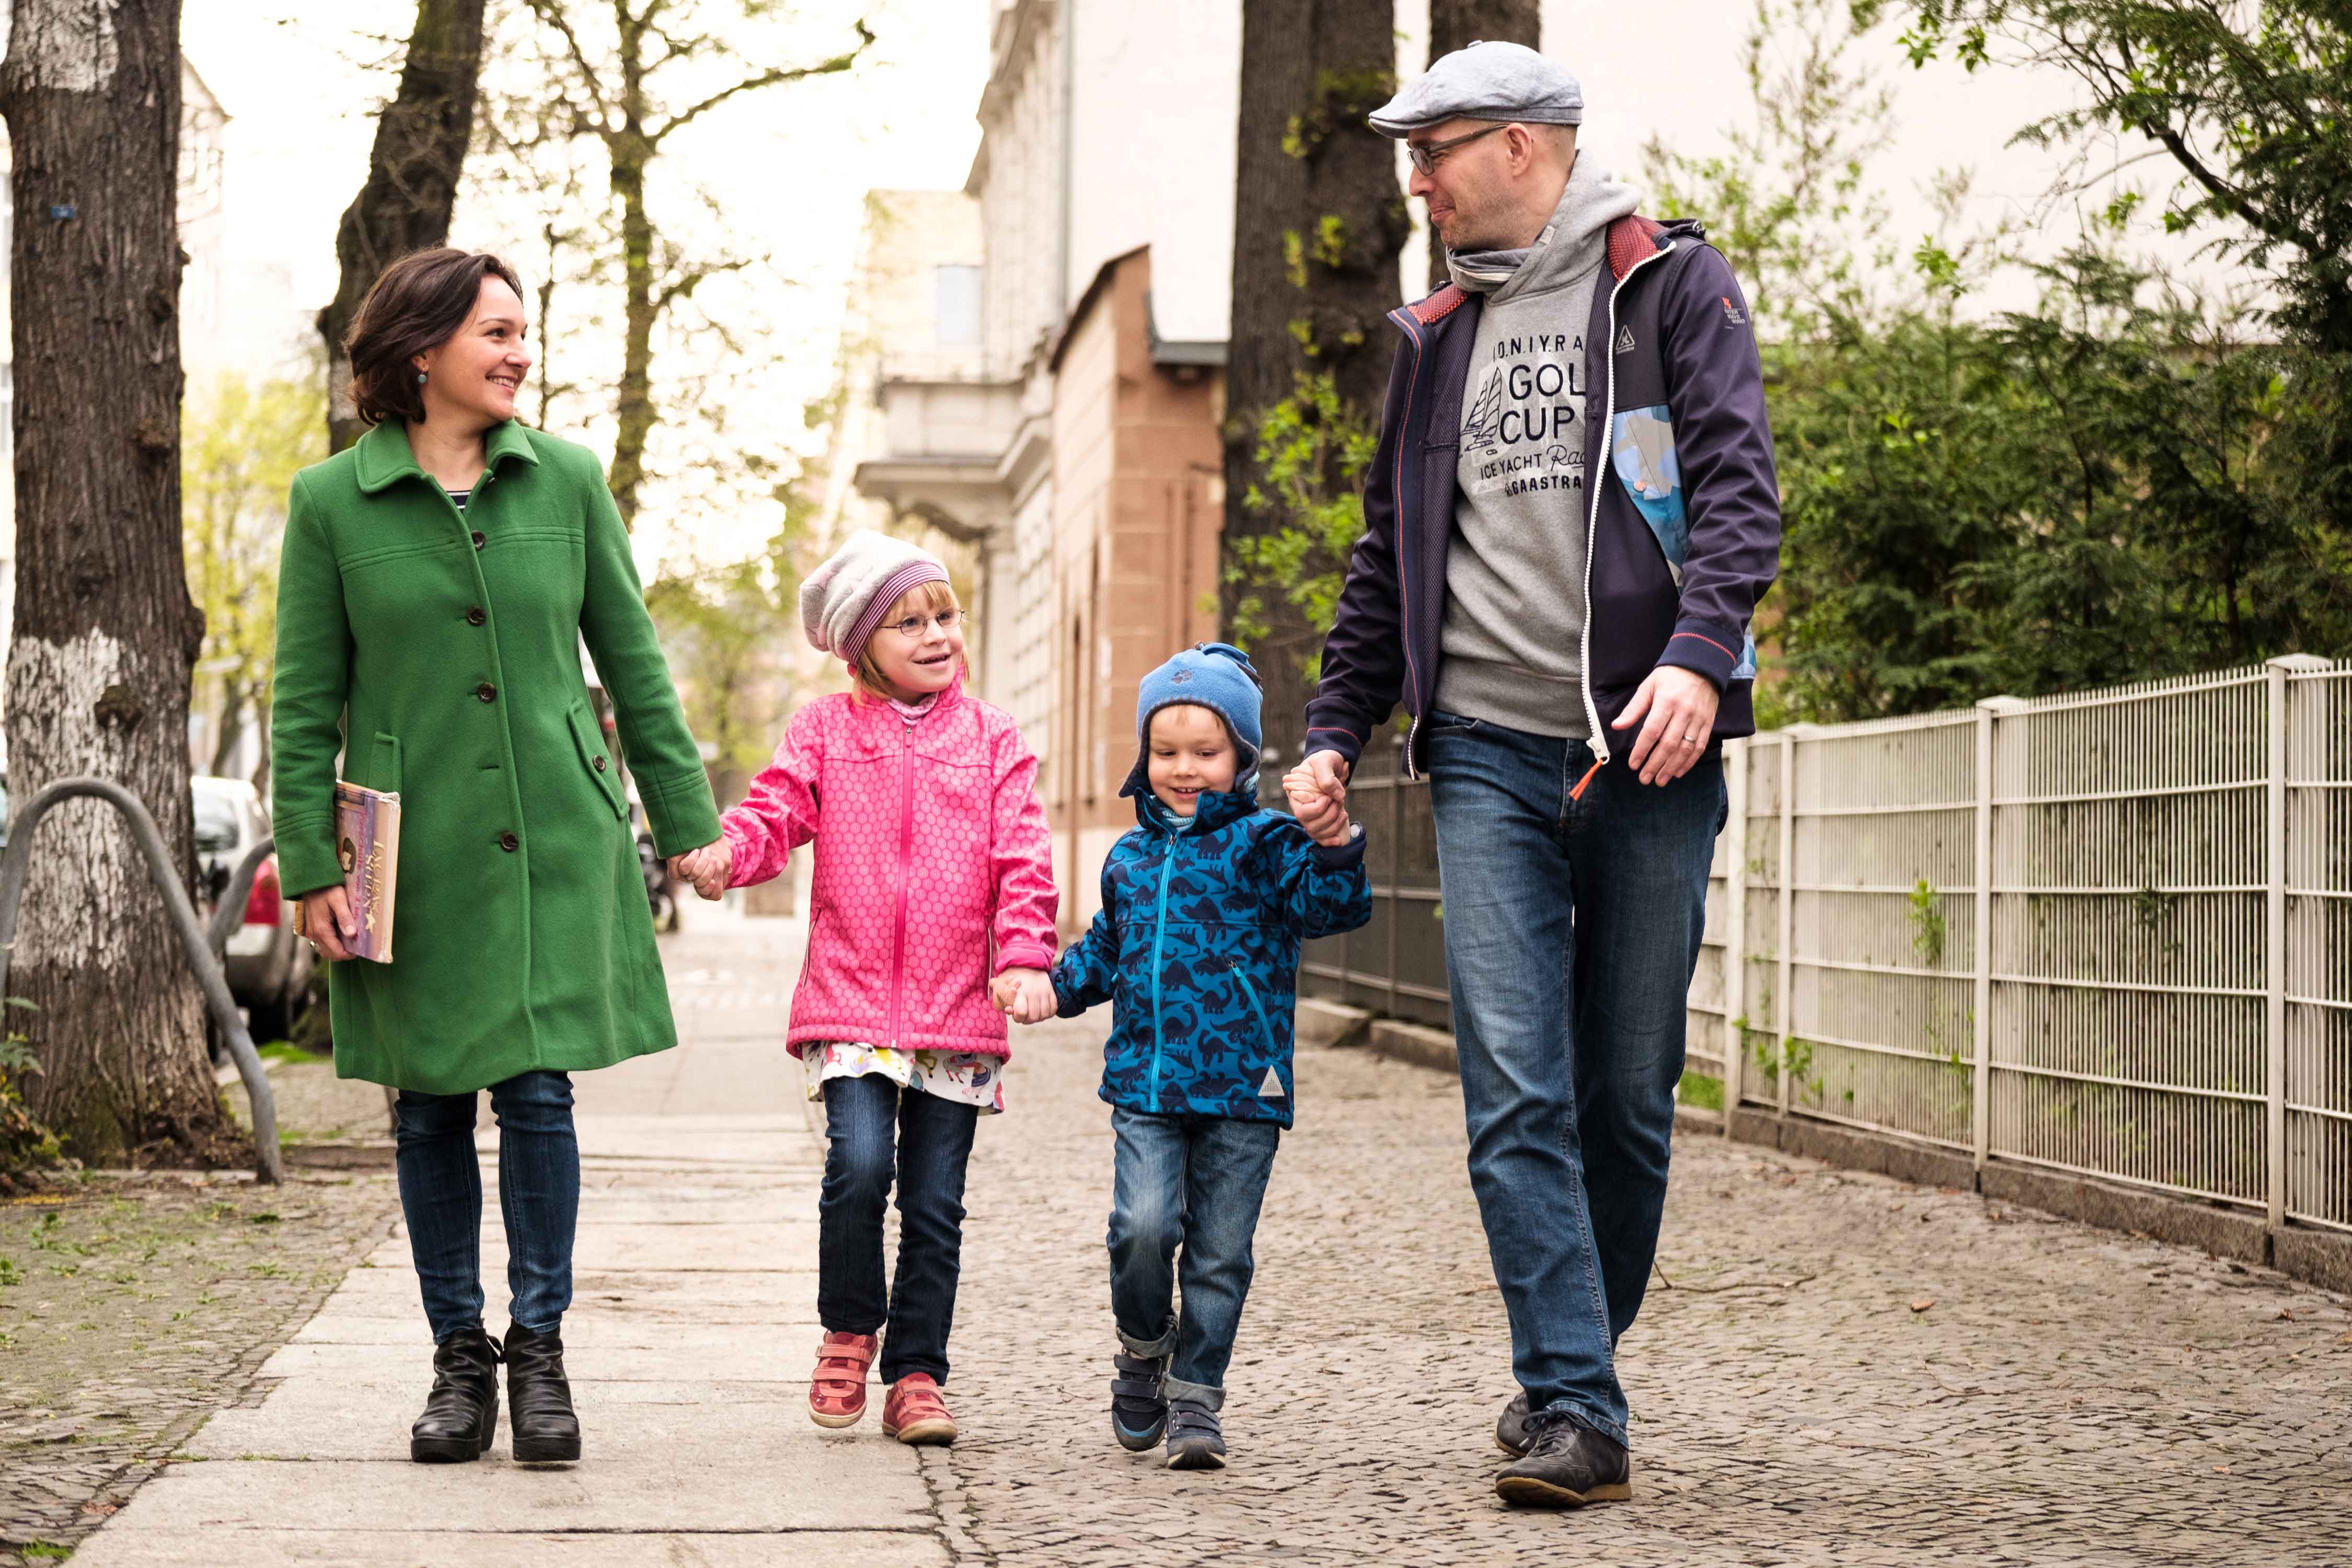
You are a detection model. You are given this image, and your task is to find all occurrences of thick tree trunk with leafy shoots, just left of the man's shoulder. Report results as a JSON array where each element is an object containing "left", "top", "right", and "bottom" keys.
[{"left": 1221, "top": 0, "right": 1411, "bottom": 766}]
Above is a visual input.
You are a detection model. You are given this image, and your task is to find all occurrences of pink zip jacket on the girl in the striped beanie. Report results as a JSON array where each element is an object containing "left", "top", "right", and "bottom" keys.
[{"left": 720, "top": 682, "right": 1058, "bottom": 1058}]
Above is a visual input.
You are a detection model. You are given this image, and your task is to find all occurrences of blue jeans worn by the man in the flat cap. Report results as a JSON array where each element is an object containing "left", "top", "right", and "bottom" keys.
[{"left": 1428, "top": 714, "right": 1726, "bottom": 1444}]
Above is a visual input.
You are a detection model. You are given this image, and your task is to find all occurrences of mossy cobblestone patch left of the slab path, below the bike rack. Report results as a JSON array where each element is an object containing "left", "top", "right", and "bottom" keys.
[{"left": 0, "top": 1171, "right": 398, "bottom": 1568}]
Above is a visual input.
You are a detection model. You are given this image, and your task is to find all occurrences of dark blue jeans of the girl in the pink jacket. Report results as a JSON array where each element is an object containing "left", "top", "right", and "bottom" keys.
[{"left": 816, "top": 1074, "right": 981, "bottom": 1387}]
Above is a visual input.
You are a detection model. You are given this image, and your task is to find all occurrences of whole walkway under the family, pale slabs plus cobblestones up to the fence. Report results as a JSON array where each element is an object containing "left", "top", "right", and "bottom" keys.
[{"left": 55, "top": 907, "right": 2352, "bottom": 1568}]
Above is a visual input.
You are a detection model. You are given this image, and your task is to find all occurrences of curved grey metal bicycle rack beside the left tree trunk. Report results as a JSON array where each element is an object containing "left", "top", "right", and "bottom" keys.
[{"left": 0, "top": 778, "right": 285, "bottom": 1182}]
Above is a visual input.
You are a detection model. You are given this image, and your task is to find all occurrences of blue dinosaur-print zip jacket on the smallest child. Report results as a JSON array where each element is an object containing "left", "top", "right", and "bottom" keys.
[{"left": 1054, "top": 780, "right": 1371, "bottom": 1126}]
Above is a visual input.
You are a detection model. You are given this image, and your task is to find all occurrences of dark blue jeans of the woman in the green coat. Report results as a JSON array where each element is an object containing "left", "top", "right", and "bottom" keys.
[{"left": 393, "top": 1072, "right": 581, "bottom": 1345}]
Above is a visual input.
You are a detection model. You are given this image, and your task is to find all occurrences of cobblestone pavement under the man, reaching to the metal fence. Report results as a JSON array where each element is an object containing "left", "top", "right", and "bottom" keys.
[{"left": 929, "top": 1018, "right": 2352, "bottom": 1568}]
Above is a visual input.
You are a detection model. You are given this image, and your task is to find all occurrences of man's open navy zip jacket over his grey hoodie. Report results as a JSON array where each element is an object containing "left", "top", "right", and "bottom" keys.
[{"left": 1308, "top": 216, "right": 1781, "bottom": 776}]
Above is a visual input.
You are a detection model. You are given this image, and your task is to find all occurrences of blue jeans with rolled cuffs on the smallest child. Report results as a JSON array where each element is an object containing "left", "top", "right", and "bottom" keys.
[{"left": 1110, "top": 1105, "right": 1282, "bottom": 1411}]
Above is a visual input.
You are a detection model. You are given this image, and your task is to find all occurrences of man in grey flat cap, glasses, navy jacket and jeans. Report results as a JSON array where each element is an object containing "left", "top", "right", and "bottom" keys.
[{"left": 1301, "top": 42, "right": 1781, "bottom": 1507}]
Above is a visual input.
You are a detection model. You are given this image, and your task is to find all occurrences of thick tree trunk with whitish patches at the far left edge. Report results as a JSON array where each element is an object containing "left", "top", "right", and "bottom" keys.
[{"left": 0, "top": 0, "right": 233, "bottom": 1163}]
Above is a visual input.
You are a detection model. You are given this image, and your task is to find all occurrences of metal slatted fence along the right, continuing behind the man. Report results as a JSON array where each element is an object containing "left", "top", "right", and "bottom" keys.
[{"left": 1303, "top": 658, "right": 2352, "bottom": 1229}]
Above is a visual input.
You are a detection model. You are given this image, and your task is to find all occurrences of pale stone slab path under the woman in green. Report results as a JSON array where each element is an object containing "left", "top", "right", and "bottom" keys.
[{"left": 73, "top": 910, "right": 948, "bottom": 1568}]
